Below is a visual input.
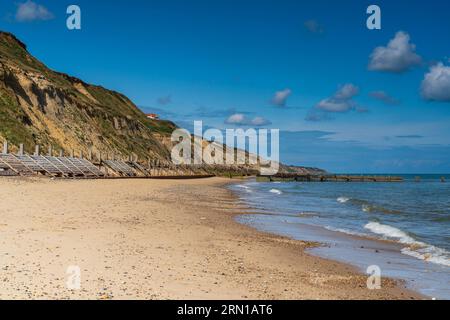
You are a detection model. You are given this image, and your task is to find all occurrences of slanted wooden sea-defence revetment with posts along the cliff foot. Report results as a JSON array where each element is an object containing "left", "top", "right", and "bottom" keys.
[{"left": 0, "top": 141, "right": 213, "bottom": 179}]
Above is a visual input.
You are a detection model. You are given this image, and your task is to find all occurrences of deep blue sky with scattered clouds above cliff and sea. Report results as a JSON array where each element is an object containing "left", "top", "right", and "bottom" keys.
[{"left": 0, "top": 0, "right": 450, "bottom": 173}]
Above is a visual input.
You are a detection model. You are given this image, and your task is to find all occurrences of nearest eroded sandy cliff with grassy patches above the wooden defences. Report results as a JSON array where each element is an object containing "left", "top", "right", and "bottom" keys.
[{"left": 0, "top": 32, "right": 175, "bottom": 160}]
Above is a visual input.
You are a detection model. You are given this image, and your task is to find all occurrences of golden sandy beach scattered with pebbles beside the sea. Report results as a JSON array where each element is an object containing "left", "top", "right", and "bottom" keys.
[{"left": 0, "top": 178, "right": 421, "bottom": 299}]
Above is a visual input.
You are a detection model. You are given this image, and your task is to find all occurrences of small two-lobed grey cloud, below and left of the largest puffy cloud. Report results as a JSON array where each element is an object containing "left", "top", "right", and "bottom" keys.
[{"left": 316, "top": 83, "right": 359, "bottom": 112}]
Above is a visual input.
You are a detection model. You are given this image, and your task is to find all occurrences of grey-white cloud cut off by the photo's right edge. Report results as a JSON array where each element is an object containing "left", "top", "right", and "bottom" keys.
[{"left": 421, "top": 63, "right": 450, "bottom": 102}]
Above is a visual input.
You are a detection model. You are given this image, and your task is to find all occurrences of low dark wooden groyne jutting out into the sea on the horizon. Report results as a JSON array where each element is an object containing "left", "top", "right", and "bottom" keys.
[{"left": 257, "top": 173, "right": 403, "bottom": 182}]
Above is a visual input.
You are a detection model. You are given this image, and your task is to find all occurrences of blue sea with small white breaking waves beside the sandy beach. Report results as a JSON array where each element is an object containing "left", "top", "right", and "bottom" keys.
[{"left": 230, "top": 174, "right": 450, "bottom": 300}]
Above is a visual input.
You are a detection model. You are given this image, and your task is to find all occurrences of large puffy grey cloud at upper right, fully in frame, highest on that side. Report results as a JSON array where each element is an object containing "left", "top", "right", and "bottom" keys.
[{"left": 369, "top": 31, "right": 422, "bottom": 73}]
